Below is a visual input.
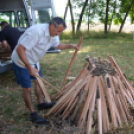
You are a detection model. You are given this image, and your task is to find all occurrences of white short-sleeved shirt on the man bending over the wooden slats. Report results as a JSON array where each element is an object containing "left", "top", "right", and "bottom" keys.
[{"left": 11, "top": 24, "right": 60, "bottom": 67}]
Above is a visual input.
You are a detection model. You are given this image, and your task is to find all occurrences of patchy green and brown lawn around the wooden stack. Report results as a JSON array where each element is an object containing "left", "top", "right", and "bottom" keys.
[{"left": 0, "top": 36, "right": 134, "bottom": 134}]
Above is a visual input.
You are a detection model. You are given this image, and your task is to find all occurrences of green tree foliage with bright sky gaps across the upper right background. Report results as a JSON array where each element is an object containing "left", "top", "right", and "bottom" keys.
[{"left": 26, "top": 0, "right": 134, "bottom": 35}]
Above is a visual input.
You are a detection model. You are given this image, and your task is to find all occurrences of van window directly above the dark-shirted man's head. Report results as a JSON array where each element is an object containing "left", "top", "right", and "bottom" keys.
[{"left": 0, "top": 12, "right": 17, "bottom": 27}]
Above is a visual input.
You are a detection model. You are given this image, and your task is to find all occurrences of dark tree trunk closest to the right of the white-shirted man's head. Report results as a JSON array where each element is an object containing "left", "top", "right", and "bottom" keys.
[{"left": 69, "top": 0, "right": 75, "bottom": 38}]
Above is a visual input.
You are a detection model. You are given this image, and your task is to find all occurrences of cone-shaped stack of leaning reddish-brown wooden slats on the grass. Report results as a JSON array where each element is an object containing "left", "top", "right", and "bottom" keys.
[{"left": 45, "top": 56, "right": 134, "bottom": 134}]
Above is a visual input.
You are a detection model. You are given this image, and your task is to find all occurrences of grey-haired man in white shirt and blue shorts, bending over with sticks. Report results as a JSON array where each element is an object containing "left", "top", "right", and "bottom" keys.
[{"left": 12, "top": 17, "right": 79, "bottom": 124}]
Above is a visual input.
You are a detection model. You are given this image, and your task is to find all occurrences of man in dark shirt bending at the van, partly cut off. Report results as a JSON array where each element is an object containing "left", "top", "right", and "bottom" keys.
[{"left": 0, "top": 21, "right": 21, "bottom": 51}]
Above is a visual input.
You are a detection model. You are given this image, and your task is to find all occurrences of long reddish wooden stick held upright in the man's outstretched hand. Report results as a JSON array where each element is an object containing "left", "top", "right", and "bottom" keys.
[{"left": 61, "top": 37, "right": 83, "bottom": 90}]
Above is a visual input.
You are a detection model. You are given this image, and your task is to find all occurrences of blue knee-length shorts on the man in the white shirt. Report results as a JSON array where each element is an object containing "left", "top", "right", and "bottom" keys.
[{"left": 12, "top": 62, "right": 42, "bottom": 88}]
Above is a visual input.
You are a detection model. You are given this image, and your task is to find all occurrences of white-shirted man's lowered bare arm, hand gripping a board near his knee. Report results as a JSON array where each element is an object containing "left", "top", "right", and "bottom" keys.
[{"left": 16, "top": 44, "right": 38, "bottom": 76}]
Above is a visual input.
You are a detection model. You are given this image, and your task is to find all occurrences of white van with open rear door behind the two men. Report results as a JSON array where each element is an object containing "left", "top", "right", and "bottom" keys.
[{"left": 0, "top": 0, "right": 60, "bottom": 73}]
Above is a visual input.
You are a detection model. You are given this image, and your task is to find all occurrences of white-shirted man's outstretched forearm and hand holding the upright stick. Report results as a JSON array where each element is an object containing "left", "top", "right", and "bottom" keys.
[{"left": 55, "top": 44, "right": 80, "bottom": 50}]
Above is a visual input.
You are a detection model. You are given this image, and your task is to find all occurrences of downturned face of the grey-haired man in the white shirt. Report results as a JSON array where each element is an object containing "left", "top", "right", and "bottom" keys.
[{"left": 49, "top": 24, "right": 64, "bottom": 37}]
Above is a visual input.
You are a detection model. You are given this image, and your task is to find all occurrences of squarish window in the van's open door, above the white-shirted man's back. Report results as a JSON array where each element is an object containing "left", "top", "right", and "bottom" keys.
[{"left": 34, "top": 8, "right": 52, "bottom": 24}]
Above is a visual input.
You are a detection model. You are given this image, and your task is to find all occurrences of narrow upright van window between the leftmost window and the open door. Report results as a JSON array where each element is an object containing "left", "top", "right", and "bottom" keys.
[{"left": 18, "top": 11, "right": 27, "bottom": 28}]
